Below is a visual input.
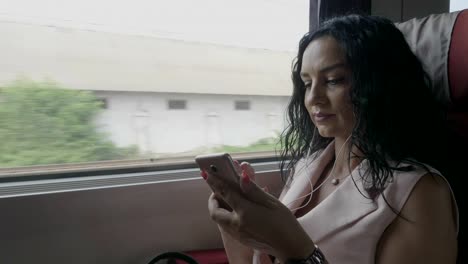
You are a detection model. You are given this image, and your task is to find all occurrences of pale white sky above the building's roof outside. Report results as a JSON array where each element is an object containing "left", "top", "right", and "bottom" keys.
[{"left": 0, "top": 0, "right": 309, "bottom": 50}]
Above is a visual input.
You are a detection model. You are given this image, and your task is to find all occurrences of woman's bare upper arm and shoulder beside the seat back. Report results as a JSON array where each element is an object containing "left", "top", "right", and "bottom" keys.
[{"left": 376, "top": 174, "right": 457, "bottom": 264}]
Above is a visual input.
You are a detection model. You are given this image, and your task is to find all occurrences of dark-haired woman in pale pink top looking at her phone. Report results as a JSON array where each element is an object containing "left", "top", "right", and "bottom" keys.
[{"left": 202, "top": 15, "right": 458, "bottom": 264}]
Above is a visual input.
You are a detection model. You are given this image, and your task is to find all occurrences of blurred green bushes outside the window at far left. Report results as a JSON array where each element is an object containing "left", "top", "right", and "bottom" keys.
[{"left": 0, "top": 80, "right": 137, "bottom": 167}]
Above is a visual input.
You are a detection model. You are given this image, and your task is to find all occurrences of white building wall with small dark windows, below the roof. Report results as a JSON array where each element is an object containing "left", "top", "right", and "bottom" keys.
[{"left": 96, "top": 91, "right": 288, "bottom": 154}]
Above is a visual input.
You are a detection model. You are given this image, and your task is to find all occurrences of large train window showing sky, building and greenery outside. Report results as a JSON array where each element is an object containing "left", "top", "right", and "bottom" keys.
[{"left": 0, "top": 0, "right": 309, "bottom": 175}]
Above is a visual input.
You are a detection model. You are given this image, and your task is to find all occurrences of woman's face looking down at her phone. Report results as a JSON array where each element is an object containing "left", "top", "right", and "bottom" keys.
[{"left": 301, "top": 36, "right": 354, "bottom": 138}]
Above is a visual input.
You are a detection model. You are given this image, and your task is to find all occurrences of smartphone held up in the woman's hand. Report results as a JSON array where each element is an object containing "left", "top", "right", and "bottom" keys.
[{"left": 195, "top": 153, "right": 240, "bottom": 186}]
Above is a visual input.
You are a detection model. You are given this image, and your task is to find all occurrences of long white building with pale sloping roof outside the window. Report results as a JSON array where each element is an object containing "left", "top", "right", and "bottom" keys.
[{"left": 0, "top": 22, "right": 295, "bottom": 154}]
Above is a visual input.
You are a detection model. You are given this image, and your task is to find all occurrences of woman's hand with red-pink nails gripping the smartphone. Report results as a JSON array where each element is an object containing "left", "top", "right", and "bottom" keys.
[{"left": 205, "top": 164, "right": 314, "bottom": 260}]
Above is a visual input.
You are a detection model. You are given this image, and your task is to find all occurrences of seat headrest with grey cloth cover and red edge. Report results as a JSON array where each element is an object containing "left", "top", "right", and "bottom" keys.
[{"left": 397, "top": 10, "right": 468, "bottom": 110}]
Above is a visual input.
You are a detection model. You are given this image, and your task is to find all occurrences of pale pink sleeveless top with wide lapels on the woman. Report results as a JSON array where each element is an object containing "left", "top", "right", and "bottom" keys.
[{"left": 253, "top": 142, "right": 458, "bottom": 264}]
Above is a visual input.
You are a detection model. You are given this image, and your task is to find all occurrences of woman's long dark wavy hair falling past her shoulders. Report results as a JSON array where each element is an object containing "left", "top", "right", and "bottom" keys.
[{"left": 281, "top": 15, "right": 446, "bottom": 197}]
